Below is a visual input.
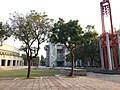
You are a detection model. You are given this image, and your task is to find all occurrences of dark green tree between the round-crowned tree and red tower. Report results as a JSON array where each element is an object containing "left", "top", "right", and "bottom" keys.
[{"left": 75, "top": 25, "right": 100, "bottom": 66}]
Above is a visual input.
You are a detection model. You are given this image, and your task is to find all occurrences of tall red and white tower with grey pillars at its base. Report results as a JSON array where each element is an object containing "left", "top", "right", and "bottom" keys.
[{"left": 100, "top": 0, "right": 118, "bottom": 70}]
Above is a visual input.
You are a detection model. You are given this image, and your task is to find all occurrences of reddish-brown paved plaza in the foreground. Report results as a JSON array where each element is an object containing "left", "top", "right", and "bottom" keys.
[{"left": 0, "top": 73, "right": 120, "bottom": 90}]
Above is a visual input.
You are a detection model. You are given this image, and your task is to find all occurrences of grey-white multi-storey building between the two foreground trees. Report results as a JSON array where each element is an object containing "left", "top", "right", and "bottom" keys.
[{"left": 45, "top": 43, "right": 68, "bottom": 67}]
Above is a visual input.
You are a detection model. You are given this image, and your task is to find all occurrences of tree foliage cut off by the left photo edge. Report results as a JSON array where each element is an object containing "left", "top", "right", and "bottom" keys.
[{"left": 0, "top": 22, "right": 11, "bottom": 45}]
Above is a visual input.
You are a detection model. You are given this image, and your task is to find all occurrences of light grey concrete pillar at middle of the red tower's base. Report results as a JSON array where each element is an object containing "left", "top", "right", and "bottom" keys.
[{"left": 106, "top": 34, "right": 112, "bottom": 70}]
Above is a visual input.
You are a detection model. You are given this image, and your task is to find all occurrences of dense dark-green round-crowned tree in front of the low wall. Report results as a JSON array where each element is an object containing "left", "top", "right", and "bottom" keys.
[{"left": 49, "top": 18, "right": 83, "bottom": 76}]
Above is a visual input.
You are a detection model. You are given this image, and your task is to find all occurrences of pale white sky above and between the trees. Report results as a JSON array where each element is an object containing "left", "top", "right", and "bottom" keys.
[{"left": 0, "top": 0, "right": 120, "bottom": 56}]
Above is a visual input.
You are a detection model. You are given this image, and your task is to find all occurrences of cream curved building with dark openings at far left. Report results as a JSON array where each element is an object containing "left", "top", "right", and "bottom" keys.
[{"left": 0, "top": 44, "right": 23, "bottom": 66}]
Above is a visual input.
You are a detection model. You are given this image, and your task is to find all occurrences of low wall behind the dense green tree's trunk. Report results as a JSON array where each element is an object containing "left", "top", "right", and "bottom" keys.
[{"left": 60, "top": 68, "right": 86, "bottom": 76}]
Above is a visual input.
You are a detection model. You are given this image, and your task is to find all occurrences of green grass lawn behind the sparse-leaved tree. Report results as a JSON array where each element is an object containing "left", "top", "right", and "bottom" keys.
[{"left": 0, "top": 69, "right": 60, "bottom": 78}]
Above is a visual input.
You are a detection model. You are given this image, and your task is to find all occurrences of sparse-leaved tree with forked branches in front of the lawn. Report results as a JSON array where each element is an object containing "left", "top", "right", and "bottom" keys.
[{"left": 10, "top": 10, "right": 53, "bottom": 78}]
